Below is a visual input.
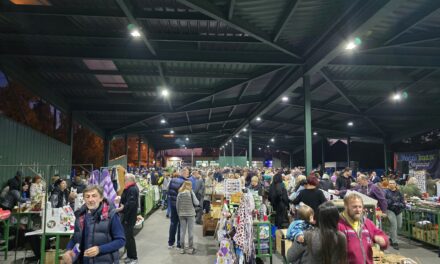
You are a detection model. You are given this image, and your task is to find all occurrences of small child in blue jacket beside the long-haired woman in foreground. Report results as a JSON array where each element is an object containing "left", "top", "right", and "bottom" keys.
[{"left": 286, "top": 203, "right": 314, "bottom": 243}]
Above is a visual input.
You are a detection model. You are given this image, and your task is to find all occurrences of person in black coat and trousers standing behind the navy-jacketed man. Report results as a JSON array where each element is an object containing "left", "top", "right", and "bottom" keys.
[{"left": 116, "top": 173, "right": 139, "bottom": 264}]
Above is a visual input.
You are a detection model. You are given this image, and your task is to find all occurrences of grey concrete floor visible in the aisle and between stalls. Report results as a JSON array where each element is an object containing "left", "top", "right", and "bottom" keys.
[{"left": 0, "top": 210, "right": 440, "bottom": 264}]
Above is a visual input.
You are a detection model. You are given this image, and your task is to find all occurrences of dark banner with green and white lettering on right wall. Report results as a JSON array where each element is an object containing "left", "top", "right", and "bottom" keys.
[{"left": 394, "top": 150, "right": 440, "bottom": 179}]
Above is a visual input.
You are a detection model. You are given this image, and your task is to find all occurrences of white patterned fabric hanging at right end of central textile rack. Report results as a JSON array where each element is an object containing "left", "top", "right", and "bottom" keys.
[{"left": 234, "top": 193, "right": 255, "bottom": 261}]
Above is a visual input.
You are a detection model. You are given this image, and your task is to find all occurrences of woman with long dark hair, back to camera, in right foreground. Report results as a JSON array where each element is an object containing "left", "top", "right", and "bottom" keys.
[{"left": 287, "top": 202, "right": 347, "bottom": 264}]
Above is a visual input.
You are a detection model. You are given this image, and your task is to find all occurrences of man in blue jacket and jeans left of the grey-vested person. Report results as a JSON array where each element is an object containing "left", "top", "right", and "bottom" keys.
[{"left": 168, "top": 168, "right": 189, "bottom": 249}]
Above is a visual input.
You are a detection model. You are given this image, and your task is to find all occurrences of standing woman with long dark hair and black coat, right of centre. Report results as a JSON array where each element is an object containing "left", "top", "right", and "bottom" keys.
[{"left": 269, "top": 173, "right": 289, "bottom": 228}]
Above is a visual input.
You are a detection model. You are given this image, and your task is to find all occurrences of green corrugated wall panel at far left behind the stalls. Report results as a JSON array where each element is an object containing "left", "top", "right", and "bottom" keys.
[{"left": 0, "top": 116, "right": 72, "bottom": 187}]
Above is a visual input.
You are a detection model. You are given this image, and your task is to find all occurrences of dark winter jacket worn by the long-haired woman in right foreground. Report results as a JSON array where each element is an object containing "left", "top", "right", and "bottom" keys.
[{"left": 286, "top": 229, "right": 346, "bottom": 264}]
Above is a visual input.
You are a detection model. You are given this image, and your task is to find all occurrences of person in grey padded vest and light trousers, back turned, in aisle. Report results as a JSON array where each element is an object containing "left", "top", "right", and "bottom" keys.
[{"left": 176, "top": 181, "right": 199, "bottom": 254}]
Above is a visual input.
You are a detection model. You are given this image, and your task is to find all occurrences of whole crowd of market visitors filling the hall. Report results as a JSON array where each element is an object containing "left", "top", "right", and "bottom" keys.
[{"left": 0, "top": 167, "right": 421, "bottom": 264}]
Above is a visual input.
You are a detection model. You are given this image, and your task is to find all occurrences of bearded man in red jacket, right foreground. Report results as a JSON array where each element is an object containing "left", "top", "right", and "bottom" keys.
[{"left": 338, "top": 193, "right": 389, "bottom": 264}]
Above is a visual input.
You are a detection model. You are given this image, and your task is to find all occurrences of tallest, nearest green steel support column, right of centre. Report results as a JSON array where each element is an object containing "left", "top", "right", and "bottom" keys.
[{"left": 303, "top": 75, "right": 312, "bottom": 175}]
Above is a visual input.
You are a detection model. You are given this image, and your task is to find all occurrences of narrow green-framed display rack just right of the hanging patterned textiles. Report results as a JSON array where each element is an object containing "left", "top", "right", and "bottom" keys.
[{"left": 253, "top": 221, "right": 272, "bottom": 264}]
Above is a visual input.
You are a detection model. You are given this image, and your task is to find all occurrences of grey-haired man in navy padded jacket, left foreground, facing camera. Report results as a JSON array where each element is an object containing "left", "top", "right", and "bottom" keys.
[{"left": 63, "top": 185, "right": 125, "bottom": 264}]
